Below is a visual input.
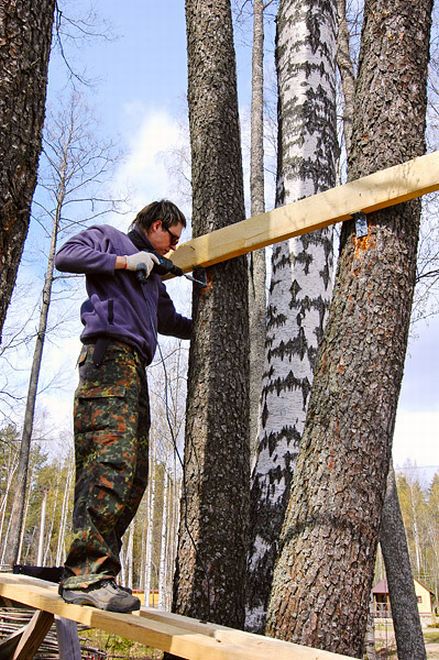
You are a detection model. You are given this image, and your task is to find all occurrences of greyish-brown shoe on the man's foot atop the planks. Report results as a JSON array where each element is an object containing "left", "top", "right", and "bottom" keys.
[{"left": 59, "top": 580, "right": 140, "bottom": 612}]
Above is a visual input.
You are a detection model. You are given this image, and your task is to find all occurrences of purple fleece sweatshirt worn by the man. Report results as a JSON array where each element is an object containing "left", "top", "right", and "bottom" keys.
[{"left": 55, "top": 225, "right": 192, "bottom": 364}]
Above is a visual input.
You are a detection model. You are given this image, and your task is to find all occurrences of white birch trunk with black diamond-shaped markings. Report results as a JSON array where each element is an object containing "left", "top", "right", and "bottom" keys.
[{"left": 246, "top": 0, "right": 338, "bottom": 632}]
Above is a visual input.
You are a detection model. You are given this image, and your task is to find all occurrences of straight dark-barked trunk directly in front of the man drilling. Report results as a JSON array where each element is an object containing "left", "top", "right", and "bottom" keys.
[{"left": 173, "top": 0, "right": 249, "bottom": 627}]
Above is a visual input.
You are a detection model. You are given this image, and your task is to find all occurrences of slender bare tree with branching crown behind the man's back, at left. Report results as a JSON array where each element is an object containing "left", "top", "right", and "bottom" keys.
[{"left": 6, "top": 95, "right": 124, "bottom": 564}]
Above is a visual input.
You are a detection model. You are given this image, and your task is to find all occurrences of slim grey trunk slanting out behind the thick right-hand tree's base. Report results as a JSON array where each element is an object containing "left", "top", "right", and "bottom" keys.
[{"left": 380, "top": 465, "right": 427, "bottom": 660}]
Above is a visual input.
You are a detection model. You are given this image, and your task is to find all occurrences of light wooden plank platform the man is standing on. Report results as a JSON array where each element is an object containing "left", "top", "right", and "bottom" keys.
[{"left": 0, "top": 573, "right": 354, "bottom": 660}]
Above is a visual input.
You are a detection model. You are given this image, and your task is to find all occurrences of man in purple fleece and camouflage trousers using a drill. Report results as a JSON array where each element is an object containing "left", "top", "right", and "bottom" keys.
[{"left": 55, "top": 200, "right": 192, "bottom": 612}]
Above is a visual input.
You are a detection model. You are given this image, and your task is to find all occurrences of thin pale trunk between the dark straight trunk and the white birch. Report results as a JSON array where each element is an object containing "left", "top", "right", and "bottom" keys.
[{"left": 249, "top": 0, "right": 266, "bottom": 456}]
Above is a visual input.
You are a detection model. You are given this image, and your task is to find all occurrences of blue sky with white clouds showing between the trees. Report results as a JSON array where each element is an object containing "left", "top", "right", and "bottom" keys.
[{"left": 3, "top": 0, "right": 439, "bottom": 478}]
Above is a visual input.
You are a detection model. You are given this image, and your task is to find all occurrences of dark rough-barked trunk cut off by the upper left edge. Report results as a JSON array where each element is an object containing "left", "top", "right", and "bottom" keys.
[{"left": 0, "top": 0, "right": 55, "bottom": 340}]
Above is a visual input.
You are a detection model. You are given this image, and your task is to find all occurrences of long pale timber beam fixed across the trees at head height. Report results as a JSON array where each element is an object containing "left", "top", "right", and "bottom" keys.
[{"left": 172, "top": 151, "right": 439, "bottom": 272}]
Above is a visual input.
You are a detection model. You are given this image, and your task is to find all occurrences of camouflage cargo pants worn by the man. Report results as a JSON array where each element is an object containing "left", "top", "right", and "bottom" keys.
[{"left": 63, "top": 341, "right": 150, "bottom": 589}]
